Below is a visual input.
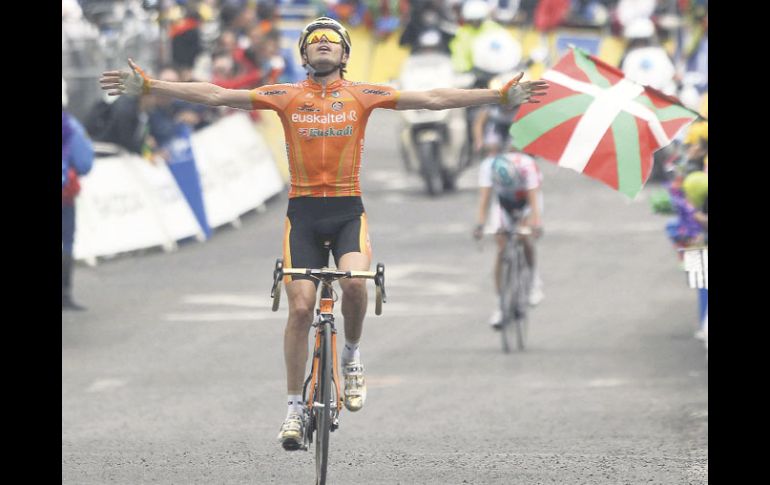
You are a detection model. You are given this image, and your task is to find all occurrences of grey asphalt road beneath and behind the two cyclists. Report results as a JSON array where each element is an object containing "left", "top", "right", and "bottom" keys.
[{"left": 62, "top": 111, "right": 708, "bottom": 485}]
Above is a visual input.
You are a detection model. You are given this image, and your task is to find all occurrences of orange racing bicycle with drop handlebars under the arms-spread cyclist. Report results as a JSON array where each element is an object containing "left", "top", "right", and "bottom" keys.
[{"left": 270, "top": 259, "right": 387, "bottom": 485}]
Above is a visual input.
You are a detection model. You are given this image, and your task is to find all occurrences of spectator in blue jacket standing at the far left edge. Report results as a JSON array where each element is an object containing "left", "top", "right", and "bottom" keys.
[{"left": 61, "top": 78, "right": 94, "bottom": 310}]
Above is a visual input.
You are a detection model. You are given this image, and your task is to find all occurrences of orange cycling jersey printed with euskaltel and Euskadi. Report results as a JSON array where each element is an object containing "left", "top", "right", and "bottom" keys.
[{"left": 251, "top": 79, "right": 399, "bottom": 198}]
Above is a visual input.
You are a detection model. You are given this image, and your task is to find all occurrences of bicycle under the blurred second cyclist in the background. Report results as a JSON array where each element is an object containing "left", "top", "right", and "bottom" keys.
[{"left": 499, "top": 226, "right": 532, "bottom": 354}]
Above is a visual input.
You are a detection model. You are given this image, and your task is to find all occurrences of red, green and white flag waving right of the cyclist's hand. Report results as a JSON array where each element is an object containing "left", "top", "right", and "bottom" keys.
[{"left": 510, "top": 47, "right": 698, "bottom": 198}]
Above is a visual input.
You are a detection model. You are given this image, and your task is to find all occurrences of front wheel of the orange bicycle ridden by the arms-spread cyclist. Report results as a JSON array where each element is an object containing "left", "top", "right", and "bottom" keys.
[{"left": 313, "top": 324, "right": 333, "bottom": 485}]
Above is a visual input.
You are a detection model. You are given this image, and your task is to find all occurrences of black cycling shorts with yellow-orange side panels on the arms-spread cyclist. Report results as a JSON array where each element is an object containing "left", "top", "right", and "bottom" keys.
[{"left": 283, "top": 197, "right": 372, "bottom": 281}]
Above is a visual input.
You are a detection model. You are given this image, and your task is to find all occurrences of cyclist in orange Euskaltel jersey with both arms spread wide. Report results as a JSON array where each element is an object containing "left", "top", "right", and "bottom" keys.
[{"left": 100, "top": 17, "right": 547, "bottom": 450}]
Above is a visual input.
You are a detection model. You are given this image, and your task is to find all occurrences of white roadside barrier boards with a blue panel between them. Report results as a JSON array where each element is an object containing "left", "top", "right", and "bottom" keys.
[{"left": 74, "top": 113, "right": 285, "bottom": 264}]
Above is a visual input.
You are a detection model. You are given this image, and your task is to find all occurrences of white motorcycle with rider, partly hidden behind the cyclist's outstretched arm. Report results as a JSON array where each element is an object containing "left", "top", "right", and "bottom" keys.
[{"left": 399, "top": 29, "right": 473, "bottom": 196}]
